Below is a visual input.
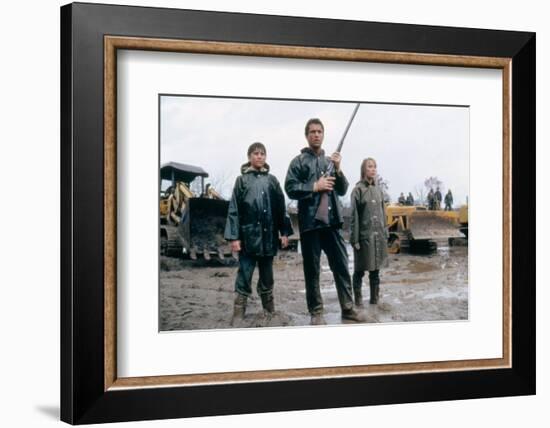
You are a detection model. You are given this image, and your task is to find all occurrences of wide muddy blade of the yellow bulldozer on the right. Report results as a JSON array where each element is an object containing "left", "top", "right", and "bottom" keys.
[{"left": 409, "top": 211, "right": 463, "bottom": 240}]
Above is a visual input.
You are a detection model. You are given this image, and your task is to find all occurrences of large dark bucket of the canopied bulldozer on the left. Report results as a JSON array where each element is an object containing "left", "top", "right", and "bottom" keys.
[{"left": 179, "top": 198, "right": 231, "bottom": 260}]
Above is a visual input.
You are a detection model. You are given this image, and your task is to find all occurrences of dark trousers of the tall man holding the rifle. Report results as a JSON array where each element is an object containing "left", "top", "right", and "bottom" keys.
[{"left": 300, "top": 227, "right": 353, "bottom": 314}]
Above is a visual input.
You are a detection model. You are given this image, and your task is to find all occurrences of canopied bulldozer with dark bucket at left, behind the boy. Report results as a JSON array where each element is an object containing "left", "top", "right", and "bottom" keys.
[{"left": 160, "top": 162, "right": 235, "bottom": 260}]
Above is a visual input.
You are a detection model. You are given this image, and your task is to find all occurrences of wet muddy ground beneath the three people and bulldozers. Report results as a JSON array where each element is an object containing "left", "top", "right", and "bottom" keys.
[{"left": 160, "top": 241, "right": 468, "bottom": 331}]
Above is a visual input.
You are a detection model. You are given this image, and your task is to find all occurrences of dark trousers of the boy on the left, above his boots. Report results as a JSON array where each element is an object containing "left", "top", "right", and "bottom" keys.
[{"left": 235, "top": 251, "right": 274, "bottom": 296}]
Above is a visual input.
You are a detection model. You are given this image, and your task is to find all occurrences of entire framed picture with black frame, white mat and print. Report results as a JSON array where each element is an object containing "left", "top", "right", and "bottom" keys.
[{"left": 61, "top": 3, "right": 535, "bottom": 424}]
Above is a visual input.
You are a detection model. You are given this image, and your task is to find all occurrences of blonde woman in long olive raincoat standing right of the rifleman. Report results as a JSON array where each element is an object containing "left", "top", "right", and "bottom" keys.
[{"left": 350, "top": 158, "right": 390, "bottom": 307}]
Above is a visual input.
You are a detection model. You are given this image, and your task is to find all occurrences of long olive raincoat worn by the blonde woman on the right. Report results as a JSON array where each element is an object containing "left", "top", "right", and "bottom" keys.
[{"left": 350, "top": 181, "right": 388, "bottom": 271}]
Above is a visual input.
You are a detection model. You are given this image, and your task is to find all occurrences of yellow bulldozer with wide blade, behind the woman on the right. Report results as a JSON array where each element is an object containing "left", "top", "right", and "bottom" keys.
[{"left": 386, "top": 204, "right": 468, "bottom": 253}]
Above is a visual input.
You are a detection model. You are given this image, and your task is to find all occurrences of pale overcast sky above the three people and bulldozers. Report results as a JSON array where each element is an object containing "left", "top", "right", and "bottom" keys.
[{"left": 160, "top": 96, "right": 469, "bottom": 205}]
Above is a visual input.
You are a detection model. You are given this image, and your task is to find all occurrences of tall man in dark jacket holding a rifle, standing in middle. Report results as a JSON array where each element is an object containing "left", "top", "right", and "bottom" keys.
[{"left": 285, "top": 119, "right": 365, "bottom": 325}]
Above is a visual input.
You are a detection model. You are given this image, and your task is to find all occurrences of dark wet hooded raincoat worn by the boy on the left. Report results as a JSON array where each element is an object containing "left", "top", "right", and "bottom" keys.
[{"left": 224, "top": 163, "right": 293, "bottom": 257}]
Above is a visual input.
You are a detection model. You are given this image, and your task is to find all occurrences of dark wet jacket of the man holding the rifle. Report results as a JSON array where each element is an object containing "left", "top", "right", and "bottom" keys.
[{"left": 285, "top": 147, "right": 349, "bottom": 233}]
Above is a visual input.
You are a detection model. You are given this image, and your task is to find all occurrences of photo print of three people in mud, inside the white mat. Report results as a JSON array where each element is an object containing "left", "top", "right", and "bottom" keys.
[{"left": 158, "top": 94, "right": 470, "bottom": 331}]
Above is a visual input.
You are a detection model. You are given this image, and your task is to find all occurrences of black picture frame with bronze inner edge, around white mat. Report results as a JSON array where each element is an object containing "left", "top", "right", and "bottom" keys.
[{"left": 61, "top": 3, "right": 535, "bottom": 424}]
